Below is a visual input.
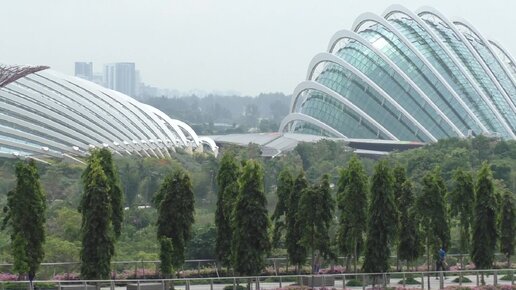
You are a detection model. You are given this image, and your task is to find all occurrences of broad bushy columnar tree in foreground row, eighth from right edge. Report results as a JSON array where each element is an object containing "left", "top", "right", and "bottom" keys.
[{"left": 298, "top": 174, "right": 334, "bottom": 271}]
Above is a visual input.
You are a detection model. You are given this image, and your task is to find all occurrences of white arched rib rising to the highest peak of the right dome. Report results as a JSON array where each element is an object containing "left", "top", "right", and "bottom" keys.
[{"left": 383, "top": 5, "right": 516, "bottom": 139}]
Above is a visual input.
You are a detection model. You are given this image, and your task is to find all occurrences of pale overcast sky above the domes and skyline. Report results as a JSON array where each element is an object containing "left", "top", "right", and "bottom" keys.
[{"left": 0, "top": 0, "right": 516, "bottom": 96}]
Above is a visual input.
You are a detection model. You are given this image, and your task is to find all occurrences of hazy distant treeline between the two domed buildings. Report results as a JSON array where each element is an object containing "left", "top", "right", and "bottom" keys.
[{"left": 142, "top": 93, "right": 291, "bottom": 135}]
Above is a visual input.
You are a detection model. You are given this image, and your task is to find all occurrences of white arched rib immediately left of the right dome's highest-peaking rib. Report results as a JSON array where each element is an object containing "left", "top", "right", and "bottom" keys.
[{"left": 353, "top": 12, "right": 489, "bottom": 133}]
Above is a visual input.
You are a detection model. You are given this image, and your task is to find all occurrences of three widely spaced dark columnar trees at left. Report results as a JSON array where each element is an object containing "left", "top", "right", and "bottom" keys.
[{"left": 2, "top": 149, "right": 198, "bottom": 281}]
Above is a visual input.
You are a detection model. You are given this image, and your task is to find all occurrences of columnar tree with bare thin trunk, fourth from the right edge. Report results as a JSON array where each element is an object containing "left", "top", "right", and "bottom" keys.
[{"left": 416, "top": 167, "right": 450, "bottom": 285}]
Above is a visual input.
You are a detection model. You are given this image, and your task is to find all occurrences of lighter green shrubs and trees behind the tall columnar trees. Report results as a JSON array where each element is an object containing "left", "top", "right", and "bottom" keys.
[{"left": 0, "top": 137, "right": 516, "bottom": 268}]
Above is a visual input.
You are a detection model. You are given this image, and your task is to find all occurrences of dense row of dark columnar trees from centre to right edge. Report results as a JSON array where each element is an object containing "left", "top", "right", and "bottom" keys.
[{"left": 212, "top": 154, "right": 516, "bottom": 275}]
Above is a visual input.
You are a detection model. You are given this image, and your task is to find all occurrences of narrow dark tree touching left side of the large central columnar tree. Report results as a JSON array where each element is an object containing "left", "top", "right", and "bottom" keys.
[{"left": 215, "top": 153, "right": 239, "bottom": 267}]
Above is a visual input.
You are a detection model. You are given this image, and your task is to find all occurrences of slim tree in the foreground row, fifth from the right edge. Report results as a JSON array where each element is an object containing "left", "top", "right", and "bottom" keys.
[{"left": 398, "top": 179, "right": 421, "bottom": 262}]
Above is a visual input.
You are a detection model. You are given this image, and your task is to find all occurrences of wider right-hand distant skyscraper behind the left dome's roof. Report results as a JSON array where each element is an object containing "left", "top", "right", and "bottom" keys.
[{"left": 104, "top": 62, "right": 136, "bottom": 97}]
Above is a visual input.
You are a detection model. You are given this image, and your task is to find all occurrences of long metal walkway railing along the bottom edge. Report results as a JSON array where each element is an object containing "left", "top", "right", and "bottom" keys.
[{"left": 0, "top": 269, "right": 516, "bottom": 290}]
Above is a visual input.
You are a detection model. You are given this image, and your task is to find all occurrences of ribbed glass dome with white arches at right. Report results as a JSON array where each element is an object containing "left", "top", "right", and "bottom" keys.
[{"left": 280, "top": 6, "right": 516, "bottom": 142}]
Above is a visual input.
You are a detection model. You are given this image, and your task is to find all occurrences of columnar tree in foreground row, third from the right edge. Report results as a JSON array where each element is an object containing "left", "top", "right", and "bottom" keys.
[{"left": 448, "top": 168, "right": 475, "bottom": 266}]
